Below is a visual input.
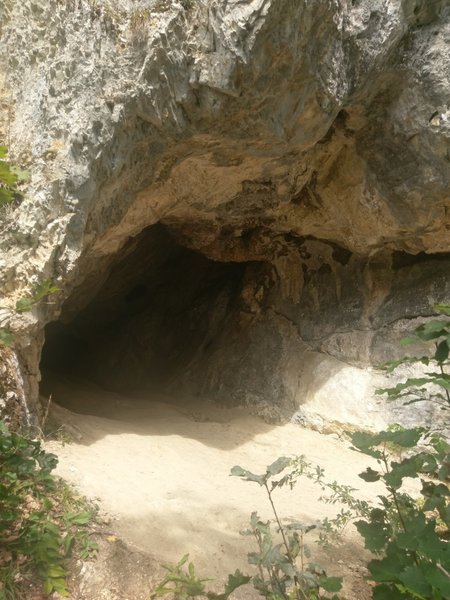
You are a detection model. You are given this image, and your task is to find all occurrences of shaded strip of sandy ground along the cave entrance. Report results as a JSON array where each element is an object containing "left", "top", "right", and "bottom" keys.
[{"left": 42, "top": 374, "right": 274, "bottom": 450}]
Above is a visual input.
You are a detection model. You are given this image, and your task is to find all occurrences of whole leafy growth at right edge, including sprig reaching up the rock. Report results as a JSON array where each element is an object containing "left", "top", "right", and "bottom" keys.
[{"left": 360, "top": 305, "right": 450, "bottom": 600}]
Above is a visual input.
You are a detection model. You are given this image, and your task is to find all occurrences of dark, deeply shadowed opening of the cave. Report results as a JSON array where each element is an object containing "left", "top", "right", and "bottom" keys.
[{"left": 40, "top": 224, "right": 258, "bottom": 410}]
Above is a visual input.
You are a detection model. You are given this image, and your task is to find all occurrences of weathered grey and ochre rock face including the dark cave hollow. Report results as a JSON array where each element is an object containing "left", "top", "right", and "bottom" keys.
[{"left": 0, "top": 0, "right": 450, "bottom": 427}]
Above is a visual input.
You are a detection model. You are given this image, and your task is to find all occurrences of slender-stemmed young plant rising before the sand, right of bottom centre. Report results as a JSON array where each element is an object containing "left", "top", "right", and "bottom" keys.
[{"left": 231, "top": 456, "right": 342, "bottom": 600}]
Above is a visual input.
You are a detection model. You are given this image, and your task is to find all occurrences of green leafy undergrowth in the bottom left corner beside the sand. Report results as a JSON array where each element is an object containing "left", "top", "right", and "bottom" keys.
[{"left": 0, "top": 422, "right": 94, "bottom": 600}]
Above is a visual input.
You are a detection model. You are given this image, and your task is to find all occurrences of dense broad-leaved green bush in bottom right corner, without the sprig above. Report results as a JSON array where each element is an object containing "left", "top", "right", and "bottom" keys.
[{"left": 352, "top": 428, "right": 450, "bottom": 600}]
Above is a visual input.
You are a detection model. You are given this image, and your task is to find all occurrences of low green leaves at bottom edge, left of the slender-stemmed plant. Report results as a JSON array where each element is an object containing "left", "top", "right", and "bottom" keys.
[{"left": 151, "top": 554, "right": 250, "bottom": 600}]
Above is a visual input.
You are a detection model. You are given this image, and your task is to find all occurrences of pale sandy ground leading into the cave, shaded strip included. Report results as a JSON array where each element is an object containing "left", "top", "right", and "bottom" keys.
[{"left": 43, "top": 379, "right": 380, "bottom": 600}]
